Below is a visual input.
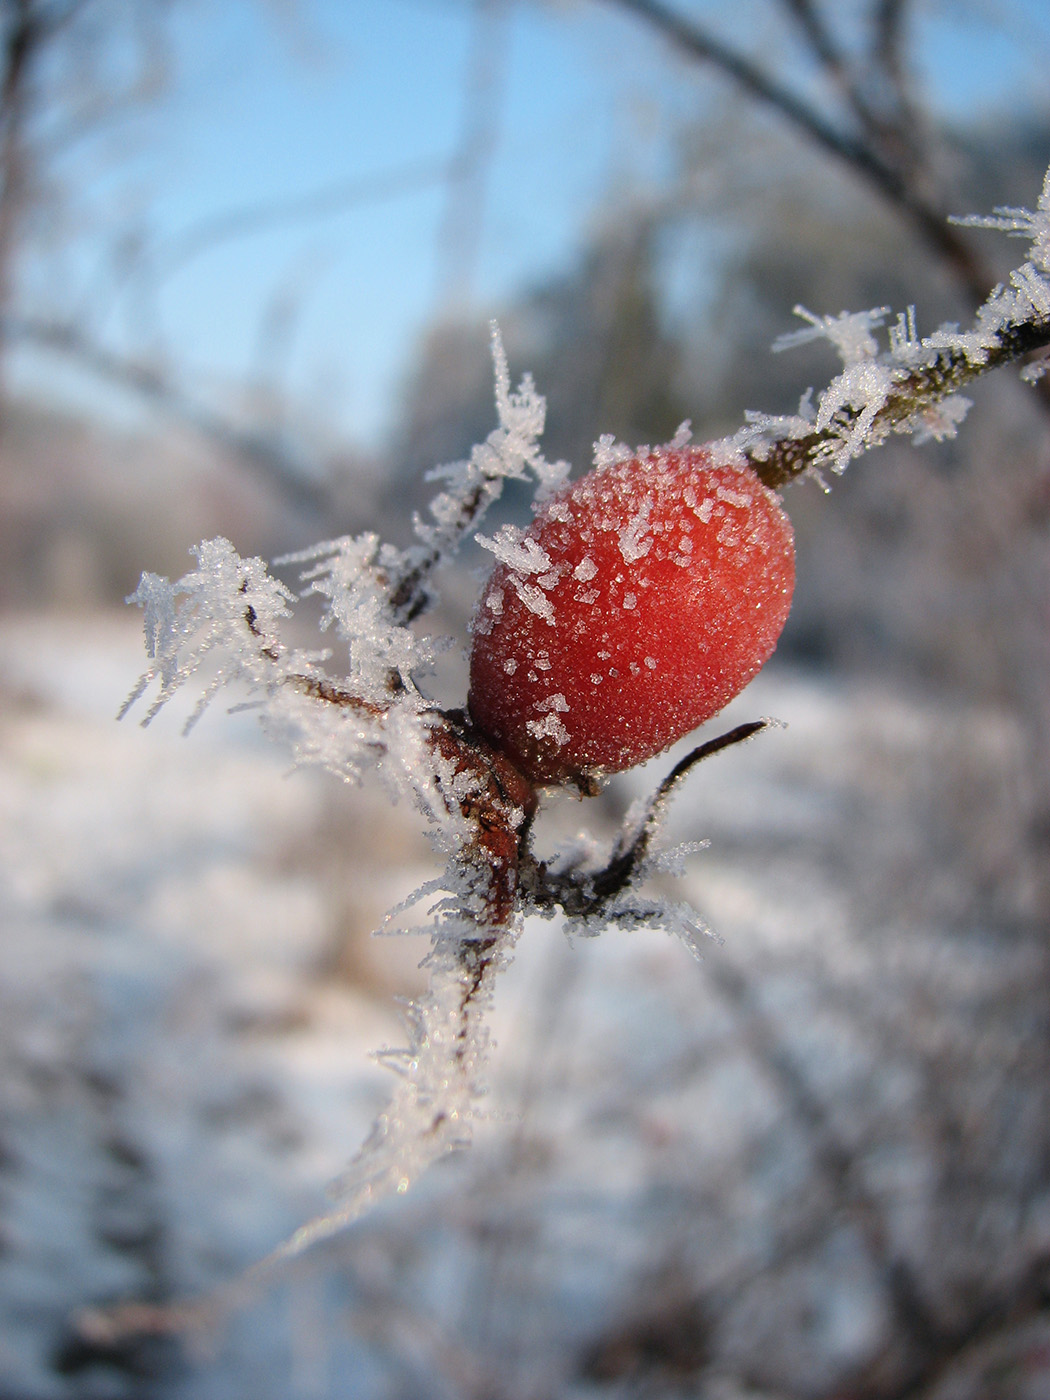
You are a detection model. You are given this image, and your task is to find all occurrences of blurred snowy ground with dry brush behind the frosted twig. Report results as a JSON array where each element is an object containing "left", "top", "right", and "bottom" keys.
[{"left": 0, "top": 615, "right": 1050, "bottom": 1400}]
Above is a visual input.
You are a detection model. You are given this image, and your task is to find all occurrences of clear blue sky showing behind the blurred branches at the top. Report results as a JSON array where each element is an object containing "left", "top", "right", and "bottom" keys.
[{"left": 14, "top": 0, "right": 1050, "bottom": 445}]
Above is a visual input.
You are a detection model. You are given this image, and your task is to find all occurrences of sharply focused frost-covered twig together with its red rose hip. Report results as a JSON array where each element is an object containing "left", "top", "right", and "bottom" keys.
[{"left": 125, "top": 174, "right": 1050, "bottom": 1276}]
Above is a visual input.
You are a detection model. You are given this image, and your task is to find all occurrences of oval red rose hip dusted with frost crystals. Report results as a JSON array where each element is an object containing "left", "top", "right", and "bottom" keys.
[{"left": 468, "top": 448, "right": 795, "bottom": 783}]
